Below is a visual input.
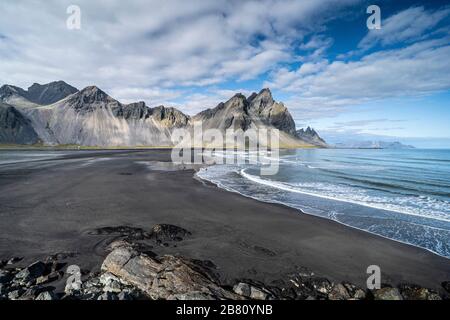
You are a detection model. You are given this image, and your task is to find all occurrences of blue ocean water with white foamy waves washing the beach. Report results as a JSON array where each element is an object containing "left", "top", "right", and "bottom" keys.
[{"left": 198, "top": 149, "right": 450, "bottom": 258}]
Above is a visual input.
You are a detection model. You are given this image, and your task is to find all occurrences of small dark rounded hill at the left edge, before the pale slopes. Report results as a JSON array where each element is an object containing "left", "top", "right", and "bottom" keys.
[{"left": 0, "top": 103, "right": 40, "bottom": 144}]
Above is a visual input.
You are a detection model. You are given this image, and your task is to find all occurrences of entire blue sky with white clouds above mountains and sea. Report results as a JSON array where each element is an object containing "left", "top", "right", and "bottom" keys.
[{"left": 0, "top": 0, "right": 450, "bottom": 148}]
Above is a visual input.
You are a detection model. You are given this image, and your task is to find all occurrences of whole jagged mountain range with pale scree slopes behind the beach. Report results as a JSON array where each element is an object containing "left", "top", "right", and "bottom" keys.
[{"left": 0, "top": 81, "right": 327, "bottom": 148}]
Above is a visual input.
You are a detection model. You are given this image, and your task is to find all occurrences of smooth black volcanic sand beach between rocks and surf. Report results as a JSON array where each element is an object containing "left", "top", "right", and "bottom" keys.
[{"left": 0, "top": 150, "right": 450, "bottom": 289}]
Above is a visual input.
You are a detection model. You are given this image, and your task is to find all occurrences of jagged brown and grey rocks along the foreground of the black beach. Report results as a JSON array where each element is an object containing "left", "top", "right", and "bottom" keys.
[{"left": 0, "top": 224, "right": 450, "bottom": 300}]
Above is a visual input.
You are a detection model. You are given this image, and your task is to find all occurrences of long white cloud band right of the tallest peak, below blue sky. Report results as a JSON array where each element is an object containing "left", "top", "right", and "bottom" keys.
[{"left": 265, "top": 37, "right": 450, "bottom": 116}]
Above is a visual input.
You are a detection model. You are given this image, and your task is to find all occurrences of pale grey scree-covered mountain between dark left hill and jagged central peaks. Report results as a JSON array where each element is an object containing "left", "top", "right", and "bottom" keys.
[{"left": 23, "top": 86, "right": 189, "bottom": 146}]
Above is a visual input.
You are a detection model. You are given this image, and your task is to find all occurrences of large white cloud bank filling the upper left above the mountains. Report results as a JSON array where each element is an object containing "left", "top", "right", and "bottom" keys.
[{"left": 0, "top": 0, "right": 360, "bottom": 106}]
